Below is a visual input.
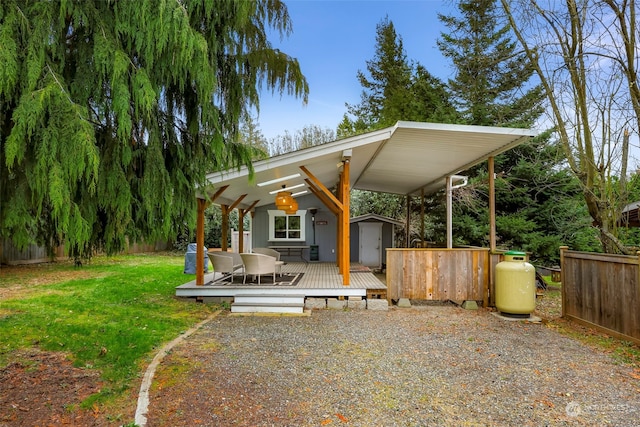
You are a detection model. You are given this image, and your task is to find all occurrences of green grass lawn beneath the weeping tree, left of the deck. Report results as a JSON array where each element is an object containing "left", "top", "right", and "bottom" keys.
[{"left": 0, "top": 254, "right": 217, "bottom": 405}]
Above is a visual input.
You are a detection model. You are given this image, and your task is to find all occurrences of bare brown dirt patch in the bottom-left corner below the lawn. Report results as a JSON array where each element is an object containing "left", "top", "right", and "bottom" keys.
[{"left": 0, "top": 351, "right": 101, "bottom": 427}]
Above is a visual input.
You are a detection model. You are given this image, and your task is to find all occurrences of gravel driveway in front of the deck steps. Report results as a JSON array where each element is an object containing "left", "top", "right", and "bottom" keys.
[{"left": 147, "top": 305, "right": 640, "bottom": 426}]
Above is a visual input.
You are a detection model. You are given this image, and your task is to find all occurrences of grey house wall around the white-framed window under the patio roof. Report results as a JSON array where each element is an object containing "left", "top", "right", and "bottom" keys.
[{"left": 251, "top": 195, "right": 338, "bottom": 262}]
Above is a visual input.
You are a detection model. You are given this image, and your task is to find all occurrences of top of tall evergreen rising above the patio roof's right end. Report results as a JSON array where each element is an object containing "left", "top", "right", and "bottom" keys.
[{"left": 438, "top": 0, "right": 544, "bottom": 127}]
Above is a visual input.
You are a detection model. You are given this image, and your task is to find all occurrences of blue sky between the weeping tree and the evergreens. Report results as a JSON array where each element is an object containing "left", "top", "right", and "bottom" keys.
[{"left": 257, "top": 0, "right": 456, "bottom": 139}]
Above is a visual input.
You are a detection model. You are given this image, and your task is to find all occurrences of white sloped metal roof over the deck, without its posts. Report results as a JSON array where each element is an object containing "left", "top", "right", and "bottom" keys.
[{"left": 202, "top": 122, "right": 537, "bottom": 208}]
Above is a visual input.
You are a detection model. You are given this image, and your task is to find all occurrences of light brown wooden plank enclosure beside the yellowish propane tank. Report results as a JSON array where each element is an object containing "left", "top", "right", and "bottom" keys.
[{"left": 387, "top": 248, "right": 490, "bottom": 305}]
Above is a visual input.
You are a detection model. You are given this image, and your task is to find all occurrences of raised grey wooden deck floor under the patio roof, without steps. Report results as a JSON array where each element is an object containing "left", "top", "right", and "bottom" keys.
[{"left": 176, "top": 262, "right": 387, "bottom": 298}]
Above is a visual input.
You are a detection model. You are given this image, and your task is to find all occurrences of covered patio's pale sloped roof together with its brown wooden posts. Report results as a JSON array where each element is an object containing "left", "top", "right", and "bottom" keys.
[{"left": 179, "top": 121, "right": 537, "bottom": 310}]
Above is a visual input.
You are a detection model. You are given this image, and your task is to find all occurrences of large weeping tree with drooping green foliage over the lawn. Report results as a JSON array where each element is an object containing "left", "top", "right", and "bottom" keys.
[{"left": 0, "top": 0, "right": 308, "bottom": 257}]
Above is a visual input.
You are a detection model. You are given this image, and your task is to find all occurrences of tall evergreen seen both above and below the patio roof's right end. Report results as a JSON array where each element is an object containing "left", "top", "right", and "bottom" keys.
[{"left": 438, "top": 0, "right": 595, "bottom": 263}]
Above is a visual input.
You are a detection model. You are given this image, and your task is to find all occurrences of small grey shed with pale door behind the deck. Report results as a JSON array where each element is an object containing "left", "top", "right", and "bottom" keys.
[{"left": 349, "top": 214, "right": 403, "bottom": 269}]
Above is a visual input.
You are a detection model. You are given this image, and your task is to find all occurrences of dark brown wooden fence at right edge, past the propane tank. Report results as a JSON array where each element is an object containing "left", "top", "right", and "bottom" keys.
[{"left": 560, "top": 246, "right": 640, "bottom": 343}]
